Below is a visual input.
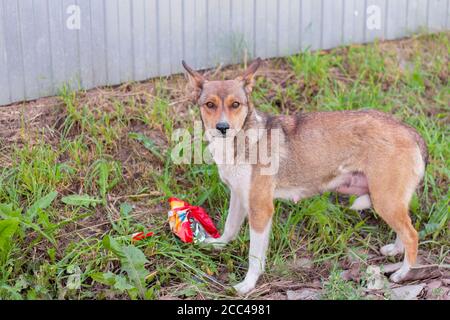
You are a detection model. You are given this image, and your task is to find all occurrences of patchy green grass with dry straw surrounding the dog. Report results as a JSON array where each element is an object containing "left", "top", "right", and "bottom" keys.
[{"left": 0, "top": 33, "right": 450, "bottom": 299}]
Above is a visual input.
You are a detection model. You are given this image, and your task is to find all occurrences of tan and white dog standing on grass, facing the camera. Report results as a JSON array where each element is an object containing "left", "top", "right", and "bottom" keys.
[{"left": 182, "top": 58, "right": 428, "bottom": 295}]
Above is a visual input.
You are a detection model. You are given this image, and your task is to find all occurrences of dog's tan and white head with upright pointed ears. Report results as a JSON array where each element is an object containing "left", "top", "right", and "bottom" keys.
[{"left": 182, "top": 58, "right": 262, "bottom": 137}]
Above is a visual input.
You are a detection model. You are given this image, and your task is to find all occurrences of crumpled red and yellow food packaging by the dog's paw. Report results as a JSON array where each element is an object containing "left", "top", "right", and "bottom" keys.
[{"left": 168, "top": 198, "right": 220, "bottom": 243}]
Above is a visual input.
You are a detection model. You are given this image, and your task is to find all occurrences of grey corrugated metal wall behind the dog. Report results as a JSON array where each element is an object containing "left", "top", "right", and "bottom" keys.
[{"left": 0, "top": 0, "right": 450, "bottom": 105}]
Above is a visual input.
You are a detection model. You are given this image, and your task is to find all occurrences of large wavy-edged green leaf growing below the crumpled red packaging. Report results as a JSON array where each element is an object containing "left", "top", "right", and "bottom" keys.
[{"left": 103, "top": 236, "right": 148, "bottom": 298}]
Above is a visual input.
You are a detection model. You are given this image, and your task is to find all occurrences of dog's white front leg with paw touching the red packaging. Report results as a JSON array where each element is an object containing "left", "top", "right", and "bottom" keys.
[{"left": 206, "top": 189, "right": 246, "bottom": 248}]
